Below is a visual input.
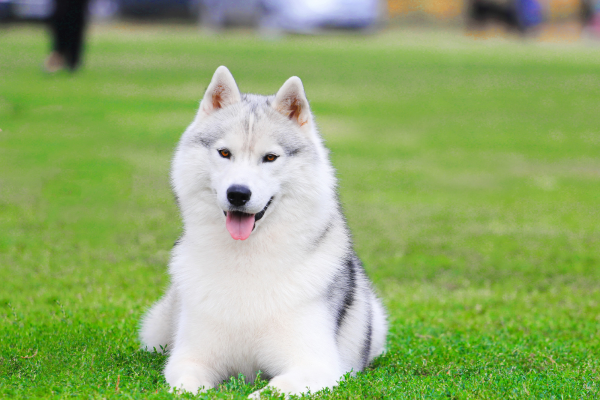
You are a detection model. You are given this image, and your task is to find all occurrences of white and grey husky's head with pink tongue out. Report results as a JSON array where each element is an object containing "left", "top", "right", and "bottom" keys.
[{"left": 172, "top": 66, "right": 330, "bottom": 240}]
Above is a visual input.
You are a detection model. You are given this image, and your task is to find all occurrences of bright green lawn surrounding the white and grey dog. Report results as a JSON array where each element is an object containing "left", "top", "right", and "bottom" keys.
[{"left": 0, "top": 26, "right": 600, "bottom": 399}]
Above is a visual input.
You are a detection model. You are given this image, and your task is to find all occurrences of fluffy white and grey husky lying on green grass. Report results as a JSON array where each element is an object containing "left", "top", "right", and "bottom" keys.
[{"left": 140, "top": 66, "right": 387, "bottom": 398}]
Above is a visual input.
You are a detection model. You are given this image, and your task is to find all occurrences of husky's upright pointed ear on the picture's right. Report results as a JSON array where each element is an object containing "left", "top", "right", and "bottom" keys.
[{"left": 273, "top": 76, "right": 311, "bottom": 127}]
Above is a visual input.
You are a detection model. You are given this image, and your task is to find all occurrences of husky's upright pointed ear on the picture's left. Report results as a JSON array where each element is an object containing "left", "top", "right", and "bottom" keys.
[{"left": 198, "top": 65, "right": 242, "bottom": 117}]
